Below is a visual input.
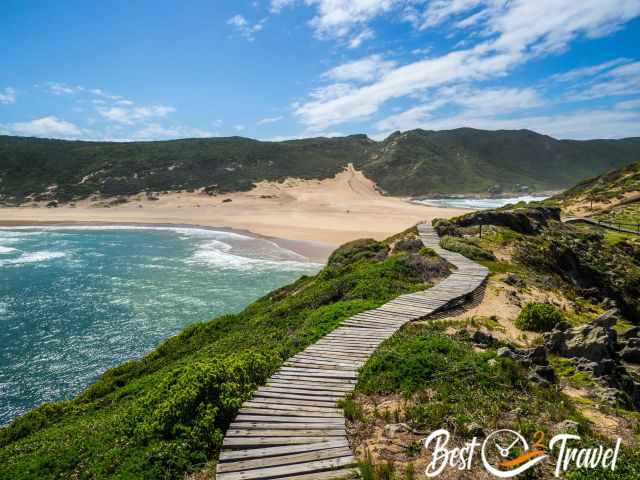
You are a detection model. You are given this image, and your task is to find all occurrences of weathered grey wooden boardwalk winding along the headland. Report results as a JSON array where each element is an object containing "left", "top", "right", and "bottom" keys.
[{"left": 216, "top": 224, "right": 489, "bottom": 480}]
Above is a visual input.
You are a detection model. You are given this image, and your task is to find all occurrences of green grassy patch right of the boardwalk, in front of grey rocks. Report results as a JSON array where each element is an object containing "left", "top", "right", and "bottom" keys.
[{"left": 356, "top": 325, "right": 584, "bottom": 436}]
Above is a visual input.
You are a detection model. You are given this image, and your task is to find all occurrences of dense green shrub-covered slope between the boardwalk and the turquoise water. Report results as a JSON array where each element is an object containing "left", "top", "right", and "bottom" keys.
[{"left": 0, "top": 237, "right": 444, "bottom": 480}]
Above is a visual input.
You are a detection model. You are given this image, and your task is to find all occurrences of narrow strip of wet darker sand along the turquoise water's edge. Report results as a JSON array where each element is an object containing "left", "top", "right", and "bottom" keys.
[{"left": 0, "top": 219, "right": 336, "bottom": 263}]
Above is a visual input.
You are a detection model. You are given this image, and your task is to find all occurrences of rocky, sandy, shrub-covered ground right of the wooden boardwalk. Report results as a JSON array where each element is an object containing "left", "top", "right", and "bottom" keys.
[{"left": 348, "top": 206, "right": 640, "bottom": 479}]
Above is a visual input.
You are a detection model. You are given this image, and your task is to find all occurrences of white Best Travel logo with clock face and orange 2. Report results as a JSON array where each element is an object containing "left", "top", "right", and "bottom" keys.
[{"left": 424, "top": 429, "right": 622, "bottom": 478}]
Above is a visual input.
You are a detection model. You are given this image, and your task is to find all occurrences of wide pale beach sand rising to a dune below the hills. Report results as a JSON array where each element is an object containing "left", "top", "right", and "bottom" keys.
[{"left": 0, "top": 167, "right": 468, "bottom": 257}]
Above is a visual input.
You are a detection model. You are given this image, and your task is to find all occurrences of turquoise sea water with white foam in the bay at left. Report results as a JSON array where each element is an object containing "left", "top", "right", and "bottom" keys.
[{"left": 0, "top": 227, "right": 320, "bottom": 425}]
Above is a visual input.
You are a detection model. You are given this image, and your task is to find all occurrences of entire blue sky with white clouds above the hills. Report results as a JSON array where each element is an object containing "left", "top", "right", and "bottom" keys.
[{"left": 0, "top": 0, "right": 640, "bottom": 141}]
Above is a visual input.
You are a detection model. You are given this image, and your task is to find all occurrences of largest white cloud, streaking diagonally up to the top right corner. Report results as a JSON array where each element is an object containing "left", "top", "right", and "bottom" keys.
[{"left": 295, "top": 0, "right": 640, "bottom": 131}]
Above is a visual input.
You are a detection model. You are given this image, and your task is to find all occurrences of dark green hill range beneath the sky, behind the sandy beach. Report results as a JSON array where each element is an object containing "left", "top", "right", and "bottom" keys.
[{"left": 0, "top": 128, "right": 640, "bottom": 203}]
